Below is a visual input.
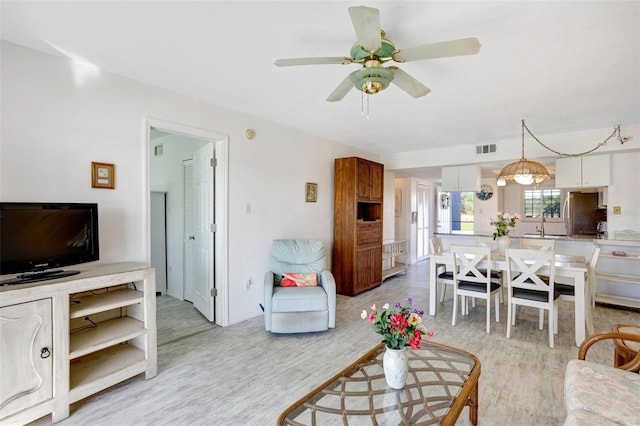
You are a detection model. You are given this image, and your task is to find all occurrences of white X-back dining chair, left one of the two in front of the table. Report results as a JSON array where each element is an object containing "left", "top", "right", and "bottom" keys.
[{"left": 451, "top": 245, "right": 501, "bottom": 333}]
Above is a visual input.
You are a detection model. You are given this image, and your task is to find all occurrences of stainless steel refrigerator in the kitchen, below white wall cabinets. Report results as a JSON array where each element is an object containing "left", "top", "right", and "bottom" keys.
[{"left": 562, "top": 192, "right": 607, "bottom": 235}]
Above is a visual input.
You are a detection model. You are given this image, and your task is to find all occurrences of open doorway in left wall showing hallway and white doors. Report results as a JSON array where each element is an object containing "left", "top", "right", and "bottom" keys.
[{"left": 148, "top": 120, "right": 228, "bottom": 339}]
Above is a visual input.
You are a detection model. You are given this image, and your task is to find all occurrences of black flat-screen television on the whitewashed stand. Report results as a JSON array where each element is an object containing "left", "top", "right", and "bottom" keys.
[{"left": 0, "top": 202, "right": 100, "bottom": 285}]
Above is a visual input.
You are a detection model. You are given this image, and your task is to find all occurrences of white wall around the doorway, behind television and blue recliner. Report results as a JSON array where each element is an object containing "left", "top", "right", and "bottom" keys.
[{"left": 0, "top": 42, "right": 379, "bottom": 324}]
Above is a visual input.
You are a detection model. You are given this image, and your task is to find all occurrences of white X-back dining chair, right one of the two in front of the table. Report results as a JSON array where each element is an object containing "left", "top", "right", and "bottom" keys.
[{"left": 505, "top": 248, "right": 560, "bottom": 348}]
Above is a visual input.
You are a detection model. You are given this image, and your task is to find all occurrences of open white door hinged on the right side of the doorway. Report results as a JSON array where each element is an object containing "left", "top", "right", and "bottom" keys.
[{"left": 192, "top": 143, "right": 215, "bottom": 321}]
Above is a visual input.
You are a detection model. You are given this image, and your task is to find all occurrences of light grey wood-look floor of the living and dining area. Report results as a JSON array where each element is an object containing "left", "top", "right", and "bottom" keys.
[{"left": 36, "top": 262, "right": 640, "bottom": 426}]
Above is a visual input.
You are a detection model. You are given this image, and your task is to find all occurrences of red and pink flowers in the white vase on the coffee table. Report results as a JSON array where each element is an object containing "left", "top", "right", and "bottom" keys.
[{"left": 360, "top": 298, "right": 433, "bottom": 349}]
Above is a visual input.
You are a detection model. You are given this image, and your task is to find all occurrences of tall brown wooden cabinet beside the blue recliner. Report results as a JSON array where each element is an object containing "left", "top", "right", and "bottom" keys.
[{"left": 332, "top": 157, "right": 384, "bottom": 296}]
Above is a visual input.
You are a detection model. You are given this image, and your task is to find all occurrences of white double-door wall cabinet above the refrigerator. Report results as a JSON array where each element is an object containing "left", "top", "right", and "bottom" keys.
[{"left": 556, "top": 154, "right": 611, "bottom": 188}]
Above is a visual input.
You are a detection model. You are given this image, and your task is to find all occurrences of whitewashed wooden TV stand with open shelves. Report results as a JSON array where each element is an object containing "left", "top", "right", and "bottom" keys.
[{"left": 0, "top": 263, "right": 157, "bottom": 424}]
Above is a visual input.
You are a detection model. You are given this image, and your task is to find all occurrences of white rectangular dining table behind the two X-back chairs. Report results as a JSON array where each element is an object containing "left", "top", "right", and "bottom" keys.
[{"left": 429, "top": 250, "right": 593, "bottom": 346}]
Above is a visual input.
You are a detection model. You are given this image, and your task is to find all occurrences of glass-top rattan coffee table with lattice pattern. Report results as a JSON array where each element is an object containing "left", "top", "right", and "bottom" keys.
[{"left": 277, "top": 341, "right": 480, "bottom": 426}]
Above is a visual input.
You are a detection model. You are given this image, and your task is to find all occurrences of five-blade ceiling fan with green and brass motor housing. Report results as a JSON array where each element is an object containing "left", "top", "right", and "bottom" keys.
[{"left": 275, "top": 6, "right": 480, "bottom": 102}]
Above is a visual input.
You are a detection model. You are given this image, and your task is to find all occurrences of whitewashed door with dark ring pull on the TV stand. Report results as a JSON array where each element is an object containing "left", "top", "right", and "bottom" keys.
[{"left": 0, "top": 299, "right": 53, "bottom": 419}]
